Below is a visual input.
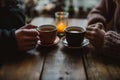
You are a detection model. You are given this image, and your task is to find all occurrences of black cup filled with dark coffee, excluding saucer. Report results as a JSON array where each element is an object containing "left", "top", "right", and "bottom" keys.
[{"left": 65, "top": 26, "right": 85, "bottom": 46}]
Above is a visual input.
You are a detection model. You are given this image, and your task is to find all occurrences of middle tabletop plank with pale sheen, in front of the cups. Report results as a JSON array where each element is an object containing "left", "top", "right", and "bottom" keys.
[{"left": 41, "top": 39, "right": 86, "bottom": 80}]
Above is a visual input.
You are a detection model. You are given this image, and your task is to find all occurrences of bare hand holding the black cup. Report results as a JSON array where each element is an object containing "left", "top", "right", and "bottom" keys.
[{"left": 86, "top": 23, "right": 105, "bottom": 48}]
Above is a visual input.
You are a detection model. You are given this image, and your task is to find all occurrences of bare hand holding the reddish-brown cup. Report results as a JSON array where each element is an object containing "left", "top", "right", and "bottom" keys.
[{"left": 15, "top": 24, "right": 39, "bottom": 51}]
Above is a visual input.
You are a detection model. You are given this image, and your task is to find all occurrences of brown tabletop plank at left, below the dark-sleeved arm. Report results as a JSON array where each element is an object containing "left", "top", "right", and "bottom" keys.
[{"left": 0, "top": 50, "right": 44, "bottom": 80}]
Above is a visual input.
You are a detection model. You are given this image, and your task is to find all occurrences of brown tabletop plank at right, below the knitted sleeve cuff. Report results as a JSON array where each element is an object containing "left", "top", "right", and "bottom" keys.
[{"left": 84, "top": 47, "right": 120, "bottom": 80}]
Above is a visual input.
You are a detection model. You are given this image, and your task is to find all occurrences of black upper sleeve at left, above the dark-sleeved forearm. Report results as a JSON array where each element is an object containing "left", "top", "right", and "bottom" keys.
[{"left": 0, "top": 7, "right": 25, "bottom": 30}]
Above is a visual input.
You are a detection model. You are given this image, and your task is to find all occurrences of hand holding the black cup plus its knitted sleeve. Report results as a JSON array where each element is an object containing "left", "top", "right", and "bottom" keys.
[{"left": 86, "top": 24, "right": 120, "bottom": 59}]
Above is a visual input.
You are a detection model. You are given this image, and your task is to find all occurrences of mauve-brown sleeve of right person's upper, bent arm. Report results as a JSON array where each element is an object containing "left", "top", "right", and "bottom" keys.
[{"left": 88, "top": 0, "right": 115, "bottom": 25}]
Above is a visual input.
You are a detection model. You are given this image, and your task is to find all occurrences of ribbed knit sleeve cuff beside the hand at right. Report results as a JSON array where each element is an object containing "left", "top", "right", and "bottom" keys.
[{"left": 103, "top": 31, "right": 120, "bottom": 58}]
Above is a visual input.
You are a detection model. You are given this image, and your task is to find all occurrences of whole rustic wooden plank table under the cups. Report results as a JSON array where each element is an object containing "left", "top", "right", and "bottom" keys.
[{"left": 0, "top": 18, "right": 120, "bottom": 80}]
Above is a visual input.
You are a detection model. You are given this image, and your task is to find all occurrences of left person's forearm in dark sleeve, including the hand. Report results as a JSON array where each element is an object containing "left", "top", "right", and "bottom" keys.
[{"left": 0, "top": 24, "right": 39, "bottom": 55}]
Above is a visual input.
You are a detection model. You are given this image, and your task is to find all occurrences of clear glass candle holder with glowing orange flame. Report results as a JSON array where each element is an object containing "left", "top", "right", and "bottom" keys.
[{"left": 55, "top": 12, "right": 69, "bottom": 37}]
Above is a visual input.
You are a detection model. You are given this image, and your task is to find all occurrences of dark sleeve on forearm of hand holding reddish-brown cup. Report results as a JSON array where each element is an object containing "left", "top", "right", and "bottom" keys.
[{"left": 0, "top": 29, "right": 19, "bottom": 55}]
